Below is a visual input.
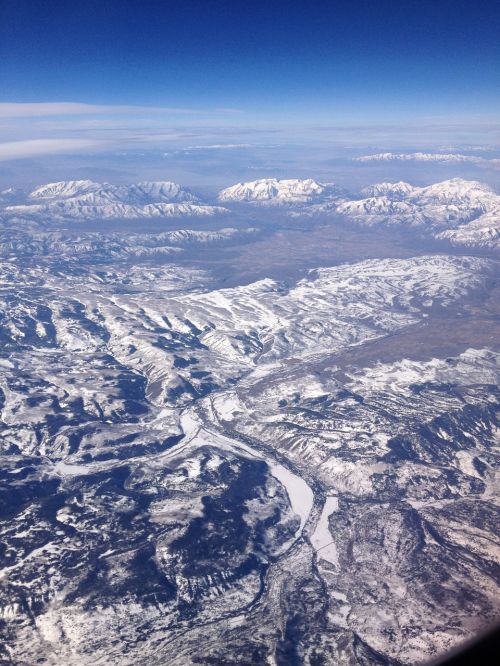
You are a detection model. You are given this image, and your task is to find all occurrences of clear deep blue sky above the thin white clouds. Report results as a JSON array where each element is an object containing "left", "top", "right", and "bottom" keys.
[{"left": 0, "top": 0, "right": 500, "bottom": 120}]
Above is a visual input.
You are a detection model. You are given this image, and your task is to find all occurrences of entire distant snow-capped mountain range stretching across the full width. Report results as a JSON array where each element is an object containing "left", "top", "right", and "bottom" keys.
[{"left": 0, "top": 175, "right": 500, "bottom": 248}]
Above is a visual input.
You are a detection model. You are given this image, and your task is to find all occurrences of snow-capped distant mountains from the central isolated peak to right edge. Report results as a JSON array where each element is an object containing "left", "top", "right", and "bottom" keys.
[{"left": 218, "top": 175, "right": 500, "bottom": 248}]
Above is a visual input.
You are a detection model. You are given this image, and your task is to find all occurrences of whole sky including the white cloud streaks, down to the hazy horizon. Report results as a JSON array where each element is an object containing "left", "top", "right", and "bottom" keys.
[{"left": 0, "top": 0, "right": 500, "bottom": 175}]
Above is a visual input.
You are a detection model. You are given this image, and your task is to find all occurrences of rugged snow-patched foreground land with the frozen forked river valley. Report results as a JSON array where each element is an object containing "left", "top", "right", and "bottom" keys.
[{"left": 0, "top": 250, "right": 500, "bottom": 666}]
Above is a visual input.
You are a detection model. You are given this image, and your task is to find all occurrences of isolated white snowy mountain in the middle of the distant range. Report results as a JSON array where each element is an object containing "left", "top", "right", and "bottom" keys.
[{"left": 218, "top": 178, "right": 343, "bottom": 204}]
